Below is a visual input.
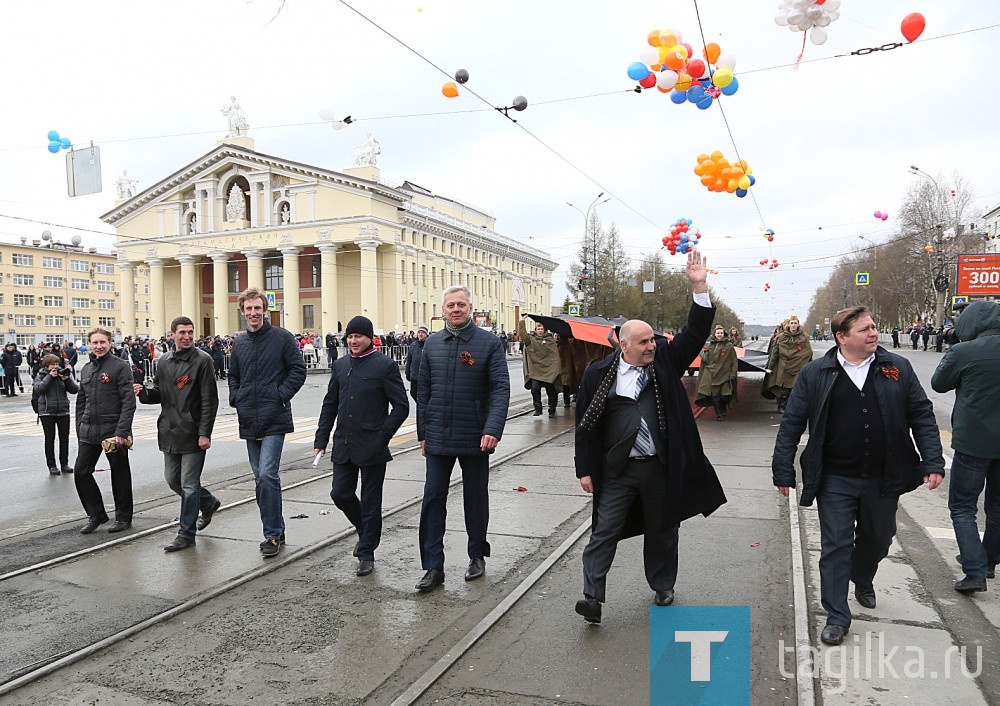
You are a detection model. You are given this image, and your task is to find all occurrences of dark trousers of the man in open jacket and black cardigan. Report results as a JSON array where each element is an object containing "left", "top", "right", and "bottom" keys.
[{"left": 816, "top": 475, "right": 899, "bottom": 628}]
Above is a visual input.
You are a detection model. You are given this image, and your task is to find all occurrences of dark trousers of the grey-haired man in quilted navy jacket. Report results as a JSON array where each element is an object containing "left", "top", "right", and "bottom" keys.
[{"left": 420, "top": 454, "right": 490, "bottom": 571}]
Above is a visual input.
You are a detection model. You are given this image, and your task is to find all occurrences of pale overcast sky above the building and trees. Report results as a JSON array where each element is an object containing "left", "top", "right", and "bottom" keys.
[{"left": 0, "top": 0, "right": 1000, "bottom": 323}]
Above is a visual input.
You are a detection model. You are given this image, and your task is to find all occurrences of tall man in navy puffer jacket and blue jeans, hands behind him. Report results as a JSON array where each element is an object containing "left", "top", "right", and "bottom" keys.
[{"left": 229, "top": 287, "right": 306, "bottom": 557}]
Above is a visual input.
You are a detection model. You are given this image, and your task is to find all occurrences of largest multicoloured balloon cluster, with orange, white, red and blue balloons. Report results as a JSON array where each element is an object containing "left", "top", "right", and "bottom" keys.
[{"left": 628, "top": 27, "right": 740, "bottom": 110}]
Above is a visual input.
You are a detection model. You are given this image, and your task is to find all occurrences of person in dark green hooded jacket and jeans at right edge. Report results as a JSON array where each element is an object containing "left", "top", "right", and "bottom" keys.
[{"left": 931, "top": 301, "right": 1000, "bottom": 593}]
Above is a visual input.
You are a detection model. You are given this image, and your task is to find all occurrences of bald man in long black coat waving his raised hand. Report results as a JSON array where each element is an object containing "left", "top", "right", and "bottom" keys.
[{"left": 576, "top": 251, "right": 726, "bottom": 623}]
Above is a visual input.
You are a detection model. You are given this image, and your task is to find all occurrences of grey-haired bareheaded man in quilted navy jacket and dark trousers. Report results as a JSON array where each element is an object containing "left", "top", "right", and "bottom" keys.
[{"left": 416, "top": 286, "right": 510, "bottom": 591}]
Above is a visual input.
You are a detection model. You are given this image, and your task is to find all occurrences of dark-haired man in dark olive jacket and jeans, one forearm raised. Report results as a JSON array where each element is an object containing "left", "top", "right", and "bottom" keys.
[{"left": 134, "top": 316, "right": 222, "bottom": 552}]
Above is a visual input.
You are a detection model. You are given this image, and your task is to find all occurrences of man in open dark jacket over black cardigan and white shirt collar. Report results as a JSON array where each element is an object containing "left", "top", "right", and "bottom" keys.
[{"left": 771, "top": 306, "right": 944, "bottom": 645}]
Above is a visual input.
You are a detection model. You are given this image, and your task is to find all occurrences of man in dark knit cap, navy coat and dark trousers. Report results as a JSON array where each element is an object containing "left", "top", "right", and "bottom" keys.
[{"left": 313, "top": 316, "right": 410, "bottom": 576}]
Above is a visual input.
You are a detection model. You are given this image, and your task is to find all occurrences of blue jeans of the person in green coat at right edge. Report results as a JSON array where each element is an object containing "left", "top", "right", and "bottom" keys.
[{"left": 948, "top": 451, "right": 1000, "bottom": 579}]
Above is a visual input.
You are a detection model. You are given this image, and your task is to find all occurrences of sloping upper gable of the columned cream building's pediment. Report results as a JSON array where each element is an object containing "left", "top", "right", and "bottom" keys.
[{"left": 101, "top": 144, "right": 402, "bottom": 225}]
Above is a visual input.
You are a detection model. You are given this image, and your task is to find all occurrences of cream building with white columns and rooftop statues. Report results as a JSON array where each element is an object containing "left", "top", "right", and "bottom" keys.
[{"left": 101, "top": 135, "right": 557, "bottom": 337}]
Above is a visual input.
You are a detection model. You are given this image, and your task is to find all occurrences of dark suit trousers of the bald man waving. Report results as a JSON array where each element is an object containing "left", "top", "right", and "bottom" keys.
[{"left": 583, "top": 459, "right": 678, "bottom": 603}]
